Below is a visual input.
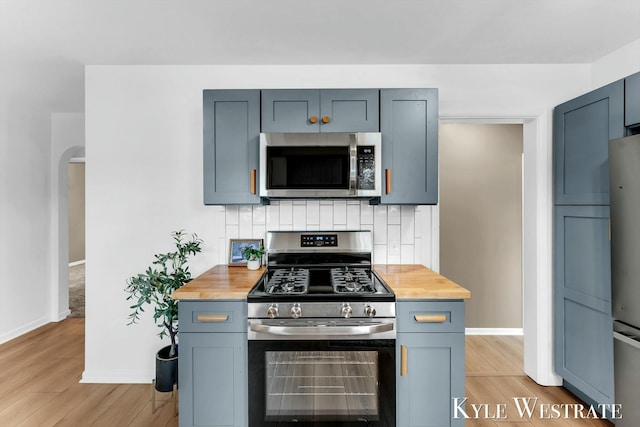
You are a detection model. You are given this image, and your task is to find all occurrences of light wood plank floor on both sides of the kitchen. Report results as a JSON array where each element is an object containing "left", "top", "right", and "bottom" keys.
[{"left": 0, "top": 318, "right": 613, "bottom": 427}]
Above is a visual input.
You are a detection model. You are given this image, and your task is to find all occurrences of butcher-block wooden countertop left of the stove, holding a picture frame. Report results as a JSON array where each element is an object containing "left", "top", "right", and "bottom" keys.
[{"left": 172, "top": 265, "right": 265, "bottom": 300}]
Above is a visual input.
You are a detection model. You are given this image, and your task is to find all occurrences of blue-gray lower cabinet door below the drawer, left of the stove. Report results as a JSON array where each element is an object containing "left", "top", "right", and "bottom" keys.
[{"left": 178, "top": 333, "right": 248, "bottom": 427}]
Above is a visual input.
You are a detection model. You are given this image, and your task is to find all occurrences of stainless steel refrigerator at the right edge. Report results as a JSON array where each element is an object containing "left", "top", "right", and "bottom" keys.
[{"left": 609, "top": 135, "right": 640, "bottom": 427}]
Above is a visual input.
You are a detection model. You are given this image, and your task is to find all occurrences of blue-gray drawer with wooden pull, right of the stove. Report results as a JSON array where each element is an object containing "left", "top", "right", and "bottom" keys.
[{"left": 396, "top": 301, "right": 464, "bottom": 332}]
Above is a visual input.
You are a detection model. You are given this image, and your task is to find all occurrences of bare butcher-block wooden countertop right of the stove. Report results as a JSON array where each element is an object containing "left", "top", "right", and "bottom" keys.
[{"left": 373, "top": 264, "right": 471, "bottom": 300}]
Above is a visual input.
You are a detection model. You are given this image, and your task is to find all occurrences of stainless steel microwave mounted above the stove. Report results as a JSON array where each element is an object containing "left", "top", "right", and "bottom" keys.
[{"left": 260, "top": 132, "right": 382, "bottom": 198}]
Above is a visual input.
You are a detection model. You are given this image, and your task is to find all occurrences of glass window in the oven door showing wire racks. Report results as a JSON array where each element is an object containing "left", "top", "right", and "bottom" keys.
[{"left": 265, "top": 351, "right": 380, "bottom": 422}]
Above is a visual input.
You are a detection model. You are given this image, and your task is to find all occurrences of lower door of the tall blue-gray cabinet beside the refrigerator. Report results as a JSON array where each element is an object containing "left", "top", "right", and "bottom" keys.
[{"left": 554, "top": 206, "right": 614, "bottom": 403}]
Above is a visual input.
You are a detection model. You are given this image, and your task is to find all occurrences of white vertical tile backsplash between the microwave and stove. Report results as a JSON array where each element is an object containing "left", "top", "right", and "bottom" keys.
[{"left": 217, "top": 199, "right": 438, "bottom": 268}]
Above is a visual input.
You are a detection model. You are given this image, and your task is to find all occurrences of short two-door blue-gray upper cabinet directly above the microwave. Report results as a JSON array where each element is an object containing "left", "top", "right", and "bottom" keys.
[{"left": 262, "top": 89, "right": 380, "bottom": 133}]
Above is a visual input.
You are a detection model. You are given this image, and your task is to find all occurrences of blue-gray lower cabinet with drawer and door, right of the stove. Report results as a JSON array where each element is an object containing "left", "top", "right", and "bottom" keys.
[{"left": 396, "top": 301, "right": 465, "bottom": 427}]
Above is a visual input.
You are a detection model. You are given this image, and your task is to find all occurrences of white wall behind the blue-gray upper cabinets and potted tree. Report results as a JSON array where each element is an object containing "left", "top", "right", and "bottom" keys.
[{"left": 83, "top": 65, "right": 590, "bottom": 382}]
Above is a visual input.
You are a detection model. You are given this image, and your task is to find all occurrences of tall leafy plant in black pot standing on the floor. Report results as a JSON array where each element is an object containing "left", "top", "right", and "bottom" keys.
[{"left": 125, "top": 230, "right": 202, "bottom": 391}]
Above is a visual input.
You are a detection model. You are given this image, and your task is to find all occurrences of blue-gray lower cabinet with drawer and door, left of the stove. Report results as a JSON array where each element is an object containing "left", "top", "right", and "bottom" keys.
[{"left": 178, "top": 301, "right": 248, "bottom": 427}]
